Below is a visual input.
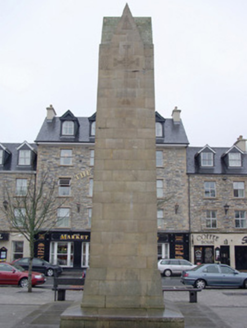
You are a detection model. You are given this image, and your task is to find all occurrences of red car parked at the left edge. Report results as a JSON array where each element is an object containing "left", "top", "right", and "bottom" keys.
[{"left": 0, "top": 262, "right": 46, "bottom": 287}]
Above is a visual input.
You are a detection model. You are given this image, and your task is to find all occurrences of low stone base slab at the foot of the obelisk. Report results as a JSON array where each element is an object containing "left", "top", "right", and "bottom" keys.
[{"left": 60, "top": 302, "right": 184, "bottom": 328}]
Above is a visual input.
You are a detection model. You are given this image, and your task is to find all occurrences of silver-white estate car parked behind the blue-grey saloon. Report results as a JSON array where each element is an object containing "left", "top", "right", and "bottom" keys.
[{"left": 158, "top": 259, "right": 196, "bottom": 277}]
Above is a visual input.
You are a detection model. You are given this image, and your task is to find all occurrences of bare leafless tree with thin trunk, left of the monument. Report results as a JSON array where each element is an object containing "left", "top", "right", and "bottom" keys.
[{"left": 1, "top": 174, "right": 61, "bottom": 292}]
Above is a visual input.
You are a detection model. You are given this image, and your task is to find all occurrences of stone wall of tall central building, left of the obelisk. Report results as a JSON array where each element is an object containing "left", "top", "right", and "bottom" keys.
[{"left": 37, "top": 144, "right": 93, "bottom": 230}]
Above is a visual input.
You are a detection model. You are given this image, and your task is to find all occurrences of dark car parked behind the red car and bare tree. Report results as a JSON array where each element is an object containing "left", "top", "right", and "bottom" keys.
[{"left": 12, "top": 257, "right": 63, "bottom": 277}]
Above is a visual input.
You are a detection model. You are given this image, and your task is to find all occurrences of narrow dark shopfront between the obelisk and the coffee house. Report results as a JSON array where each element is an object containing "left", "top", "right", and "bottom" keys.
[{"left": 158, "top": 232, "right": 189, "bottom": 260}]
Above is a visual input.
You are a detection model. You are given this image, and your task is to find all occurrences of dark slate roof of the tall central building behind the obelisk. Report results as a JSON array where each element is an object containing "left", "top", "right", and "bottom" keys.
[{"left": 35, "top": 113, "right": 189, "bottom": 145}]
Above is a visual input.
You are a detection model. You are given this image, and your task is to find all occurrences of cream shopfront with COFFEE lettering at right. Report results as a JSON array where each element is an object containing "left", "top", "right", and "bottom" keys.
[{"left": 191, "top": 233, "right": 247, "bottom": 270}]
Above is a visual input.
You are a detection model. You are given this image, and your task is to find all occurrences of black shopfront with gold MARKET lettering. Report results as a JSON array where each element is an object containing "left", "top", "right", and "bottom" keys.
[{"left": 35, "top": 231, "right": 90, "bottom": 269}]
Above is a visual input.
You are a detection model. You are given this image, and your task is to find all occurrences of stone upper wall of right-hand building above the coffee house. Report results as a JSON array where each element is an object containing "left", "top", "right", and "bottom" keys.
[{"left": 189, "top": 175, "right": 247, "bottom": 233}]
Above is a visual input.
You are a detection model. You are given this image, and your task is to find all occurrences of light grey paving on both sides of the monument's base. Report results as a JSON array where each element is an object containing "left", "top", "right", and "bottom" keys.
[{"left": 0, "top": 287, "right": 247, "bottom": 328}]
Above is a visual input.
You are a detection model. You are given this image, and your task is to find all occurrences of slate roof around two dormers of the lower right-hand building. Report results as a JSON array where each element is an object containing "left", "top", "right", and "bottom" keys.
[{"left": 187, "top": 147, "right": 247, "bottom": 175}]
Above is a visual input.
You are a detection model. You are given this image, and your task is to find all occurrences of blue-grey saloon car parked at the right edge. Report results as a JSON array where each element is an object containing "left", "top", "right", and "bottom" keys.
[{"left": 181, "top": 263, "right": 247, "bottom": 289}]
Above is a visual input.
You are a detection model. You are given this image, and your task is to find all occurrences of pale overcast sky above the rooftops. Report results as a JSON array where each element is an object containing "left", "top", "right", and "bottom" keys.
[{"left": 0, "top": 0, "right": 247, "bottom": 147}]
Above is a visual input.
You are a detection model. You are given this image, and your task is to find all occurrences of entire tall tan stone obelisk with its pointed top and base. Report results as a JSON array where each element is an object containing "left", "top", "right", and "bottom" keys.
[{"left": 61, "top": 5, "right": 183, "bottom": 328}]
